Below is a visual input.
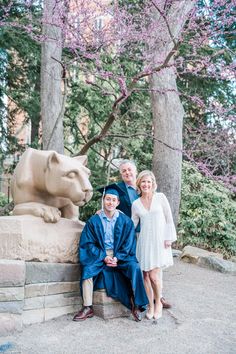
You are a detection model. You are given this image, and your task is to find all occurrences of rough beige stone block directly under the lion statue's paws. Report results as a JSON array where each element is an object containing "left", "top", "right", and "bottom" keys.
[{"left": 0, "top": 215, "right": 84, "bottom": 263}]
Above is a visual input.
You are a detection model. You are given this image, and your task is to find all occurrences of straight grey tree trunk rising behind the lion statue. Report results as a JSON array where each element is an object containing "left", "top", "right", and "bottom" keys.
[{"left": 41, "top": 0, "right": 64, "bottom": 154}]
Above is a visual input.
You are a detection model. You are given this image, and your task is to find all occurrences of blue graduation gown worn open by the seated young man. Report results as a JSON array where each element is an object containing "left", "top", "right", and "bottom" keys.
[{"left": 79, "top": 213, "right": 148, "bottom": 309}]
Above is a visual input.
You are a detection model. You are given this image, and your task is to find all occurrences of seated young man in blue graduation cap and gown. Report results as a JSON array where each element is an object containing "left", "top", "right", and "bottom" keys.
[{"left": 73, "top": 184, "right": 148, "bottom": 321}]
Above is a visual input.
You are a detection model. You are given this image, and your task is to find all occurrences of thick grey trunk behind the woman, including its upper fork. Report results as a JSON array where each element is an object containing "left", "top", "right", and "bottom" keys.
[{"left": 150, "top": 0, "right": 196, "bottom": 224}]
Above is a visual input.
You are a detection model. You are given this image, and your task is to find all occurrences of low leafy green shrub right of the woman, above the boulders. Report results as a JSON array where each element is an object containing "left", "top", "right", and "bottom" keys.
[{"left": 177, "top": 162, "right": 236, "bottom": 257}]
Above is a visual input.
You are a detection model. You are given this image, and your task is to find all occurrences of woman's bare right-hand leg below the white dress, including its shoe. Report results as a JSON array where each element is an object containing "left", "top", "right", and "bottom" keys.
[{"left": 149, "top": 268, "right": 162, "bottom": 319}]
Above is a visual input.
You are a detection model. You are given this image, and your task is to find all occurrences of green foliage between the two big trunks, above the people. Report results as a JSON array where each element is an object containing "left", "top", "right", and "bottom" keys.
[{"left": 64, "top": 50, "right": 153, "bottom": 221}]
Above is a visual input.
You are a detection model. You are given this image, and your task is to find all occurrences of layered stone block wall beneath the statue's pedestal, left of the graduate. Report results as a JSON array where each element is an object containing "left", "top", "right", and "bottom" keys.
[{"left": 0, "top": 260, "right": 82, "bottom": 335}]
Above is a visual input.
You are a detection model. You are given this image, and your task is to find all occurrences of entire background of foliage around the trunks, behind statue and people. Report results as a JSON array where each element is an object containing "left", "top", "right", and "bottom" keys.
[{"left": 0, "top": 0, "right": 236, "bottom": 256}]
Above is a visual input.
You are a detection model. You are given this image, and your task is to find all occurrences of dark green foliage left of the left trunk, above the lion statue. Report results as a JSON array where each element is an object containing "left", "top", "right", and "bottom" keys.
[{"left": 0, "top": 1, "right": 41, "bottom": 165}]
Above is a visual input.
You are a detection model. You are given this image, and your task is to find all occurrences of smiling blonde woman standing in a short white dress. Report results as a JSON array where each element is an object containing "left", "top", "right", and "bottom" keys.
[{"left": 132, "top": 170, "right": 176, "bottom": 319}]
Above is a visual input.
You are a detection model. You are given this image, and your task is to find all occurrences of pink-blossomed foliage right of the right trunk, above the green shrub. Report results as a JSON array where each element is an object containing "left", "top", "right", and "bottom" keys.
[{"left": 177, "top": 0, "right": 236, "bottom": 176}]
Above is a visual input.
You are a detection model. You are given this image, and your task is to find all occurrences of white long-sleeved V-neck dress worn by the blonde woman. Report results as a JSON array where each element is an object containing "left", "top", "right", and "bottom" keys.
[{"left": 132, "top": 192, "right": 176, "bottom": 271}]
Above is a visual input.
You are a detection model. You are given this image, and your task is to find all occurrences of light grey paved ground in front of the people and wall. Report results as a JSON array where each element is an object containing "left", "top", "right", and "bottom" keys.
[{"left": 0, "top": 260, "right": 236, "bottom": 354}]
